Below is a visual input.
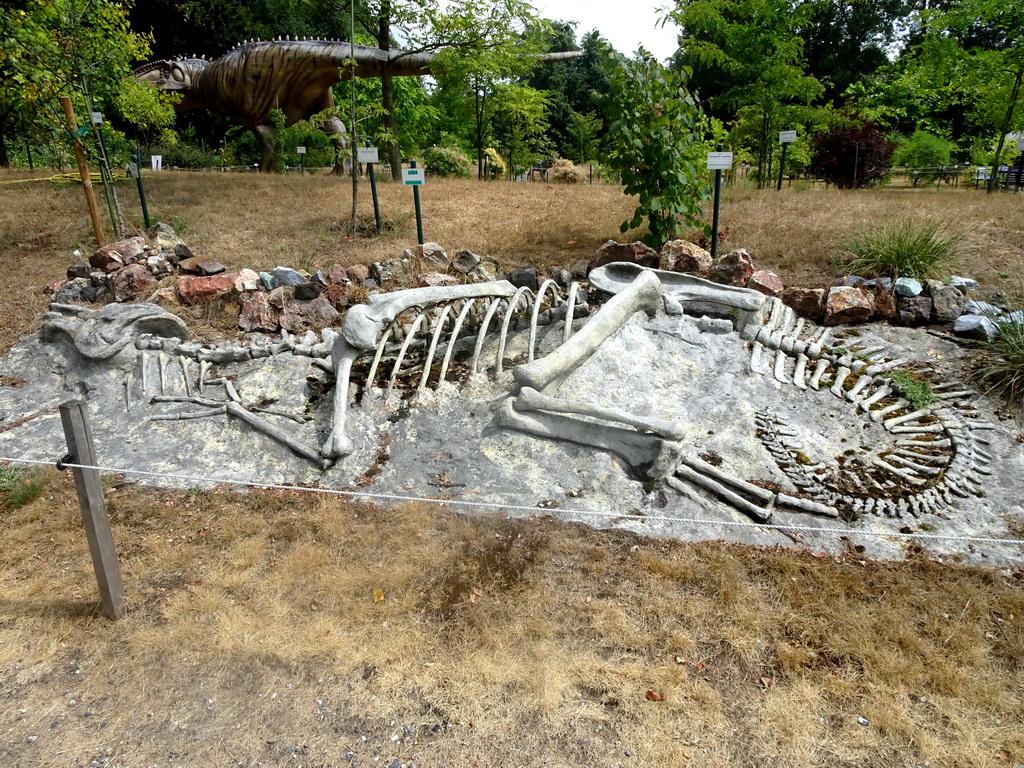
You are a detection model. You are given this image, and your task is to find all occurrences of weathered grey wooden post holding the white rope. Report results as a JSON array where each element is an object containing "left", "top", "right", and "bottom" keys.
[{"left": 60, "top": 400, "right": 125, "bottom": 620}]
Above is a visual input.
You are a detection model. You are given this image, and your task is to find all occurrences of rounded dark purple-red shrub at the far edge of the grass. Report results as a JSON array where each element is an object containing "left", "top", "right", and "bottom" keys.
[{"left": 811, "top": 119, "right": 896, "bottom": 189}]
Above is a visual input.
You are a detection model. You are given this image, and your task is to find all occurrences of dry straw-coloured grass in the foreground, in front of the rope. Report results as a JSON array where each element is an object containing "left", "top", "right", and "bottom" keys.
[{"left": 0, "top": 471, "right": 1024, "bottom": 767}]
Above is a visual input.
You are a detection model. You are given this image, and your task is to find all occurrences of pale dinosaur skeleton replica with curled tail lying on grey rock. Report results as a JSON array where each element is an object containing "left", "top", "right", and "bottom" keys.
[{"left": 42, "top": 264, "right": 993, "bottom": 522}]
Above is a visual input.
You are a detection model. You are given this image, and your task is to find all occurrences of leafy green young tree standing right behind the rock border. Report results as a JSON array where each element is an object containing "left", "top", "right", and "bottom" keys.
[{"left": 604, "top": 47, "right": 709, "bottom": 248}]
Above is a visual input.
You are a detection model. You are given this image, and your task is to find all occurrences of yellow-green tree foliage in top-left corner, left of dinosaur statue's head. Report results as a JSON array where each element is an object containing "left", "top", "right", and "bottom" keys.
[{"left": 0, "top": 0, "right": 159, "bottom": 166}]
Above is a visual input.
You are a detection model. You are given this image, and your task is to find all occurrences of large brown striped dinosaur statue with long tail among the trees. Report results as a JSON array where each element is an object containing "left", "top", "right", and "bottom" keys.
[{"left": 135, "top": 40, "right": 583, "bottom": 173}]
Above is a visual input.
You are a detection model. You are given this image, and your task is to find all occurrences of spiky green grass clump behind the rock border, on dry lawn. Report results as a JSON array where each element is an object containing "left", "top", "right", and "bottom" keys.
[{"left": 841, "top": 219, "right": 964, "bottom": 279}]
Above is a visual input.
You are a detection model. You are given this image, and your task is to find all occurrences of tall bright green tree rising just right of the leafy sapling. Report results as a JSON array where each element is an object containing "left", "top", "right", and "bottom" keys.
[{"left": 669, "top": 0, "right": 824, "bottom": 186}]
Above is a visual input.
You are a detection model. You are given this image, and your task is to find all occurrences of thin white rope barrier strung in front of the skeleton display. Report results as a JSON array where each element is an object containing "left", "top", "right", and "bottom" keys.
[{"left": 6, "top": 457, "right": 1024, "bottom": 546}]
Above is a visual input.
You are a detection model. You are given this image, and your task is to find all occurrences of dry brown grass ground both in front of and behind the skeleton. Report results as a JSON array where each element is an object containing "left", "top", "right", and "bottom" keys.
[{"left": 0, "top": 173, "right": 1024, "bottom": 768}]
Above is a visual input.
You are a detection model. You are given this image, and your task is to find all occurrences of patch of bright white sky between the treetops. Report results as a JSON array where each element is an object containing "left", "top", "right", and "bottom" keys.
[{"left": 531, "top": 0, "right": 679, "bottom": 61}]
